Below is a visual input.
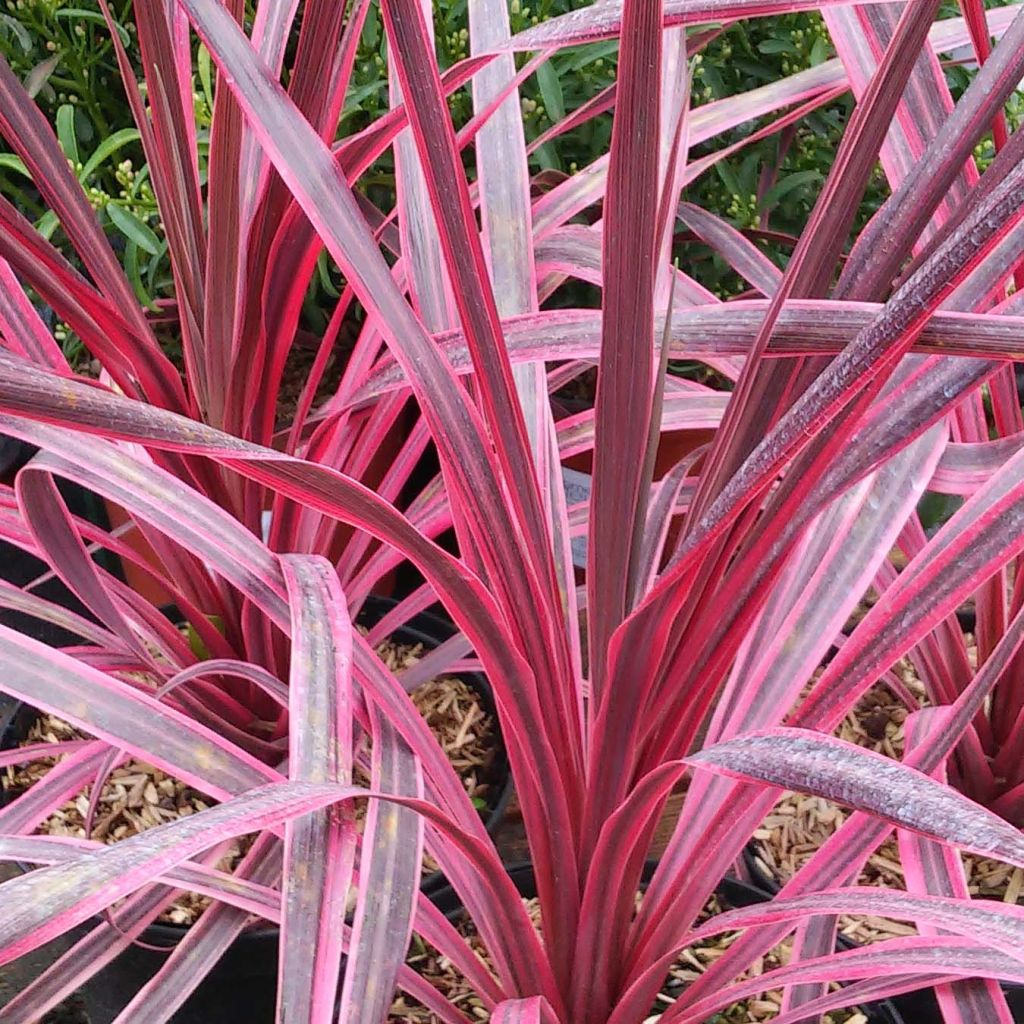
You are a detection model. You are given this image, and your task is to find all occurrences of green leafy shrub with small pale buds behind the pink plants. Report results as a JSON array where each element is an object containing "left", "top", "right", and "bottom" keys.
[{"left": 14, "top": 0, "right": 1021, "bottom": 319}]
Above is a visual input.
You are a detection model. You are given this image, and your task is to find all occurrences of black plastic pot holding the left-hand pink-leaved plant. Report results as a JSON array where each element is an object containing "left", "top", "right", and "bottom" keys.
[{"left": 0, "top": 597, "right": 511, "bottom": 1024}]
